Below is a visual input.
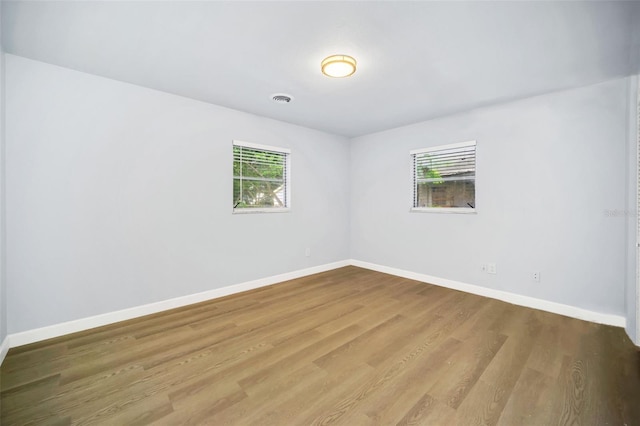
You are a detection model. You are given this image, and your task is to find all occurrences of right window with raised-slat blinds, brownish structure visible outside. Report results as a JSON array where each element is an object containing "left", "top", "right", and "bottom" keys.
[{"left": 410, "top": 141, "right": 476, "bottom": 213}]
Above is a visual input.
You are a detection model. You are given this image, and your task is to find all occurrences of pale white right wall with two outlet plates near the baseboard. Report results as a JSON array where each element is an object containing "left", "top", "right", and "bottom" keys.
[{"left": 350, "top": 79, "right": 628, "bottom": 316}]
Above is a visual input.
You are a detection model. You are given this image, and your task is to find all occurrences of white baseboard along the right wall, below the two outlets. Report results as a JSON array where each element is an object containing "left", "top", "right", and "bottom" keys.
[{"left": 350, "top": 259, "right": 626, "bottom": 328}]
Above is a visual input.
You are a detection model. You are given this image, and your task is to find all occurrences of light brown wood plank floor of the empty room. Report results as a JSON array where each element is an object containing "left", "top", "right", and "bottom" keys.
[{"left": 1, "top": 267, "right": 640, "bottom": 426}]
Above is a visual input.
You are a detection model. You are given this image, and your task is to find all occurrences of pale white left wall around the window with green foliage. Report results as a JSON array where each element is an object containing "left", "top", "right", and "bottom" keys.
[{"left": 6, "top": 55, "right": 349, "bottom": 333}]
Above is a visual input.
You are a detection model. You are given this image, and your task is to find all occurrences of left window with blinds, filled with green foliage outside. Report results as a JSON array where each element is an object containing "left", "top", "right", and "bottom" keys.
[{"left": 233, "top": 141, "right": 291, "bottom": 213}]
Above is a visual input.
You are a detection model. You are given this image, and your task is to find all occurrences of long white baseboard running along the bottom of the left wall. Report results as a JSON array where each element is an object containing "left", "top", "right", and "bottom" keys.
[{"left": 3, "top": 260, "right": 349, "bottom": 350}]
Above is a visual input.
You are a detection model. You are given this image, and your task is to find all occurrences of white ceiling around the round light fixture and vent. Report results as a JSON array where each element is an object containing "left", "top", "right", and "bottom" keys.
[{"left": 2, "top": 1, "right": 640, "bottom": 136}]
